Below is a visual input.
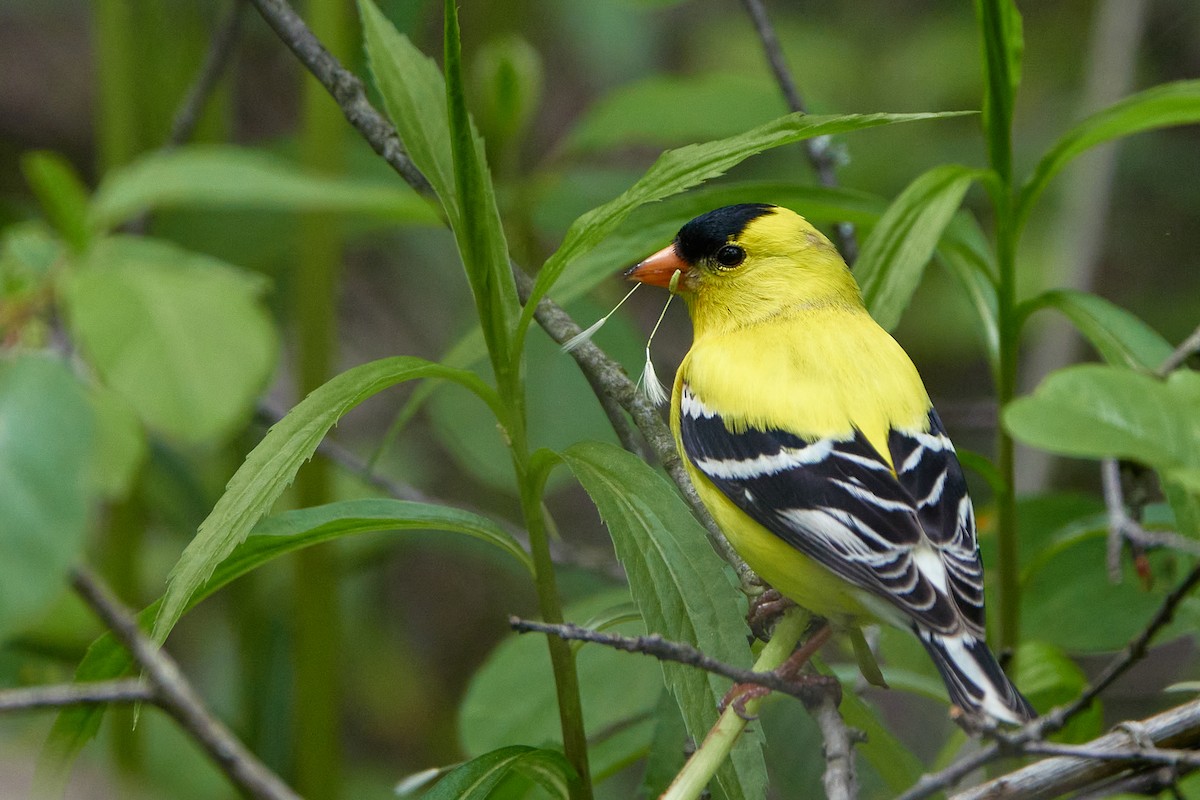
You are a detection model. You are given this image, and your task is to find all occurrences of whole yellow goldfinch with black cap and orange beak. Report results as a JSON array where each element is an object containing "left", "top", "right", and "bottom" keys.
[{"left": 626, "top": 204, "right": 1034, "bottom": 724}]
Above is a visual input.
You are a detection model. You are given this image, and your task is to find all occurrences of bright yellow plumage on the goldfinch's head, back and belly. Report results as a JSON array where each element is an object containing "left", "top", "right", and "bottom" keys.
[{"left": 671, "top": 203, "right": 930, "bottom": 622}]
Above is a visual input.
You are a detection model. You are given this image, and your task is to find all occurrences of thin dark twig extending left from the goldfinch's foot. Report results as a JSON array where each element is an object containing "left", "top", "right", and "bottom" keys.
[{"left": 509, "top": 616, "right": 824, "bottom": 700}]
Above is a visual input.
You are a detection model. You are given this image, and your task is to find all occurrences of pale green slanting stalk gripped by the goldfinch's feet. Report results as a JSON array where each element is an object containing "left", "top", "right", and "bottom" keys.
[{"left": 660, "top": 608, "right": 809, "bottom": 800}]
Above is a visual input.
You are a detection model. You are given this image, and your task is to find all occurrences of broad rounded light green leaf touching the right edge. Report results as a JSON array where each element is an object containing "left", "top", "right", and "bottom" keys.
[{"left": 1003, "top": 365, "right": 1200, "bottom": 471}]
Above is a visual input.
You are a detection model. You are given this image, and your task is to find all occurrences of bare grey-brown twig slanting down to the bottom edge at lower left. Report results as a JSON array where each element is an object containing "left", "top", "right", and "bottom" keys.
[{"left": 71, "top": 569, "right": 300, "bottom": 800}]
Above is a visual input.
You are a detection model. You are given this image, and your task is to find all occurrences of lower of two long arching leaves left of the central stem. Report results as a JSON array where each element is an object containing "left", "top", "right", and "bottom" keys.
[{"left": 37, "top": 499, "right": 516, "bottom": 786}]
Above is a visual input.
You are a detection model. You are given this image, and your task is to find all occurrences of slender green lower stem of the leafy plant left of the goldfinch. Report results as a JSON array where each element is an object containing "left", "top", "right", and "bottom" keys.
[{"left": 508, "top": 438, "right": 593, "bottom": 800}]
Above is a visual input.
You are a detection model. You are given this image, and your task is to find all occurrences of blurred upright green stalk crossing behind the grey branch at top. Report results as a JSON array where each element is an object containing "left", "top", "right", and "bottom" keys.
[{"left": 292, "top": 0, "right": 354, "bottom": 800}]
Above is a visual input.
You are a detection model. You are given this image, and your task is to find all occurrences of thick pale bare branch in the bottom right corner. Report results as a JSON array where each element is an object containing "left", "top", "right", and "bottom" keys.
[{"left": 954, "top": 699, "right": 1200, "bottom": 800}]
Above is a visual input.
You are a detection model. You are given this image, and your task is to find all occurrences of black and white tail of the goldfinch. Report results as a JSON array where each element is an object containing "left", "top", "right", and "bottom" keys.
[{"left": 917, "top": 628, "right": 1037, "bottom": 724}]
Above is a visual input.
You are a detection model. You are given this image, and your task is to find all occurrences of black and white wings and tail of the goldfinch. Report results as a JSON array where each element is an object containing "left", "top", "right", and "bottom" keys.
[{"left": 679, "top": 383, "right": 1034, "bottom": 723}]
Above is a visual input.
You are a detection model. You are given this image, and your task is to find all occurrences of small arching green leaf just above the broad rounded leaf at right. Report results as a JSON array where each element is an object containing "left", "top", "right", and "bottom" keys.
[{"left": 1018, "top": 289, "right": 1174, "bottom": 371}]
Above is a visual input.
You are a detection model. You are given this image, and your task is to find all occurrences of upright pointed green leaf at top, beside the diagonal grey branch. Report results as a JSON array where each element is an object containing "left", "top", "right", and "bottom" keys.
[{"left": 359, "top": 0, "right": 460, "bottom": 209}]
